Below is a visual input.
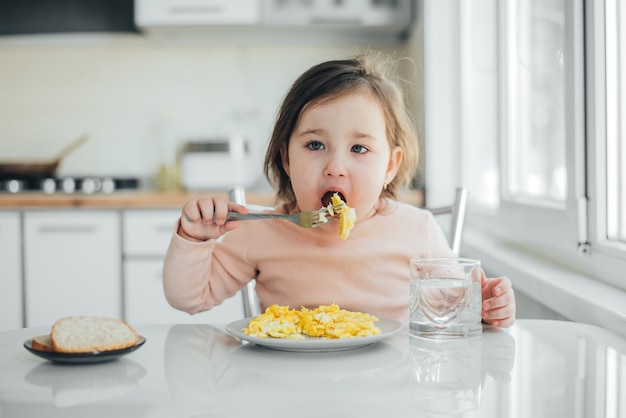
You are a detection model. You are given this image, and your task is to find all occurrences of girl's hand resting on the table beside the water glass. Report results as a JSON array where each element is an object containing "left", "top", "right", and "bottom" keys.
[{"left": 482, "top": 272, "right": 515, "bottom": 328}]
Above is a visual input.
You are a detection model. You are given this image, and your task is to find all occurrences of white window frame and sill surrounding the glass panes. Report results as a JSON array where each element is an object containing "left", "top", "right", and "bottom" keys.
[{"left": 461, "top": 0, "right": 626, "bottom": 289}]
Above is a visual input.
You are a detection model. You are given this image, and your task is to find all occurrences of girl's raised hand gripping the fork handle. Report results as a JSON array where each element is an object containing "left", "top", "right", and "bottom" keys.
[{"left": 178, "top": 196, "right": 248, "bottom": 241}]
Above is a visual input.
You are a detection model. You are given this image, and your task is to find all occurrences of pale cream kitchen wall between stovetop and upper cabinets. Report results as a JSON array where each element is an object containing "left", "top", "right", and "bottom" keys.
[{"left": 0, "top": 35, "right": 415, "bottom": 189}]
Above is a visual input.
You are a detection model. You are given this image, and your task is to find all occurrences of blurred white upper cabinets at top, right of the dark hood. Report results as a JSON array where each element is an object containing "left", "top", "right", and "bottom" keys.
[{"left": 135, "top": 0, "right": 415, "bottom": 41}]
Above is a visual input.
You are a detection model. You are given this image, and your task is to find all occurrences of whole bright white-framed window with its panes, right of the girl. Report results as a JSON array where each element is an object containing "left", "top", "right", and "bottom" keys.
[{"left": 460, "top": 0, "right": 626, "bottom": 289}]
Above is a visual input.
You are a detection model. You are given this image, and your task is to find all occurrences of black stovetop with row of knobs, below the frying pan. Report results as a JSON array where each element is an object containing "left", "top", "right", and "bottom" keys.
[{"left": 0, "top": 176, "right": 141, "bottom": 194}]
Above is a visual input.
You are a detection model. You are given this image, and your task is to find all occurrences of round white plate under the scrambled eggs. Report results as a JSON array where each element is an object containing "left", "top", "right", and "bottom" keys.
[{"left": 226, "top": 317, "right": 402, "bottom": 352}]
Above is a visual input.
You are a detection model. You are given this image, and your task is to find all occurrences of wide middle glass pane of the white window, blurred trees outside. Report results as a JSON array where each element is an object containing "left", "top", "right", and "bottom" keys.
[{"left": 501, "top": 0, "right": 567, "bottom": 204}]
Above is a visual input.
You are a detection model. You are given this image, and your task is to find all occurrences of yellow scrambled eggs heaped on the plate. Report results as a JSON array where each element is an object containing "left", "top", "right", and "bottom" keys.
[{"left": 243, "top": 304, "right": 380, "bottom": 339}]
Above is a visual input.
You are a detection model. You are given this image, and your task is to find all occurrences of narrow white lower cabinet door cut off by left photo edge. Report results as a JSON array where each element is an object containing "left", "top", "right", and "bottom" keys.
[{"left": 0, "top": 212, "right": 23, "bottom": 332}]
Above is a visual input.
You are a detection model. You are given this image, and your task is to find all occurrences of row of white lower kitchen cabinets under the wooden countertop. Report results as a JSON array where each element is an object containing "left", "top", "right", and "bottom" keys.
[{"left": 15, "top": 209, "right": 244, "bottom": 331}]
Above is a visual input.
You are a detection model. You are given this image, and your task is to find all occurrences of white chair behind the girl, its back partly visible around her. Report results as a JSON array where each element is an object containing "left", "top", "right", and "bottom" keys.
[{"left": 229, "top": 187, "right": 467, "bottom": 318}]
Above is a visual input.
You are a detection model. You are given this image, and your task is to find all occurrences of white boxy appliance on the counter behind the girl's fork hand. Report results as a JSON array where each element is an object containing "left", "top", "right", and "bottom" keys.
[{"left": 180, "top": 135, "right": 259, "bottom": 191}]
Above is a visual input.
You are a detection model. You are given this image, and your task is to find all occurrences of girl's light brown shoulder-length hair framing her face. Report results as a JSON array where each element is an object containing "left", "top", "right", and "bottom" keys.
[{"left": 264, "top": 52, "right": 419, "bottom": 210}]
